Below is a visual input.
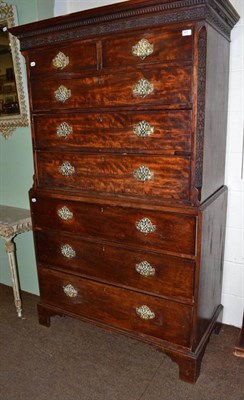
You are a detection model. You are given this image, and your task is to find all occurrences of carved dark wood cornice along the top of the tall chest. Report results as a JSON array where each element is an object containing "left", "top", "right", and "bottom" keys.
[{"left": 10, "top": 0, "right": 239, "bottom": 50}]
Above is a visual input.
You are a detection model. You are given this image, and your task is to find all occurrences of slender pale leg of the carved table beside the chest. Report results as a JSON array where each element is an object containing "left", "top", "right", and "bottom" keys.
[{"left": 5, "top": 239, "right": 22, "bottom": 318}]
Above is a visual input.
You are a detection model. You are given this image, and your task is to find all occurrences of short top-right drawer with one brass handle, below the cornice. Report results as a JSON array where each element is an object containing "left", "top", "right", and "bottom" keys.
[{"left": 103, "top": 27, "right": 193, "bottom": 68}]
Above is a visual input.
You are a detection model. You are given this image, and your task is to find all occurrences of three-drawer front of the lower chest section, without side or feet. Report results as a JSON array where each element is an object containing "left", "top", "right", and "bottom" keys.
[{"left": 31, "top": 195, "right": 198, "bottom": 348}]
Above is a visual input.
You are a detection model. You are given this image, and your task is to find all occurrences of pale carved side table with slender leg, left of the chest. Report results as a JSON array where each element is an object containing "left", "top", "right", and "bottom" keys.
[{"left": 0, "top": 205, "right": 32, "bottom": 317}]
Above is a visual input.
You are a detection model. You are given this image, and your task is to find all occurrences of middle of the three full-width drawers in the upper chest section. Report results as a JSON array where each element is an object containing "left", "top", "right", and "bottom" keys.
[{"left": 34, "top": 110, "right": 192, "bottom": 153}]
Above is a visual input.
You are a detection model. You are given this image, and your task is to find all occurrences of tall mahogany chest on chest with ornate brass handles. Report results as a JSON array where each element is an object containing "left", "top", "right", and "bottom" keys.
[{"left": 11, "top": 0, "right": 238, "bottom": 382}]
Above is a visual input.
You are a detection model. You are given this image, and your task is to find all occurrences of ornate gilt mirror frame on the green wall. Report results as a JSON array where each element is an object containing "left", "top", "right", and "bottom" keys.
[{"left": 0, "top": 0, "right": 29, "bottom": 139}]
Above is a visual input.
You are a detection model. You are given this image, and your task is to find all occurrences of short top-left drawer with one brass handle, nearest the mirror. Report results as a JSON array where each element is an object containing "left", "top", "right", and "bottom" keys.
[{"left": 28, "top": 42, "right": 97, "bottom": 77}]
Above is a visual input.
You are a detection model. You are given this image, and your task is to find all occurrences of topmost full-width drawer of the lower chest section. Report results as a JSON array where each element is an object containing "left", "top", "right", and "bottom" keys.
[{"left": 31, "top": 196, "right": 196, "bottom": 256}]
